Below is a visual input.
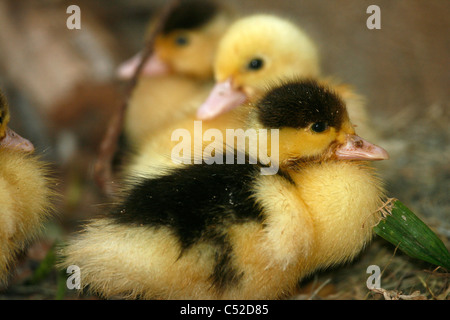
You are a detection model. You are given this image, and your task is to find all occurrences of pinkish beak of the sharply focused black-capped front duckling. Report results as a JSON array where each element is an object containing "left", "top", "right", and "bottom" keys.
[{"left": 334, "top": 134, "right": 389, "bottom": 161}]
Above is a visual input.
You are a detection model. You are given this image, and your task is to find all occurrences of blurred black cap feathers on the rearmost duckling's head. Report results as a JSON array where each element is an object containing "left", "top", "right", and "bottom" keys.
[{"left": 163, "top": 0, "right": 219, "bottom": 34}]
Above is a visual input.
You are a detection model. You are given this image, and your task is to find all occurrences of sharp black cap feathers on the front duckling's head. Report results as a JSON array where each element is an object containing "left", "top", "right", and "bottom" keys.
[{"left": 256, "top": 80, "right": 348, "bottom": 130}]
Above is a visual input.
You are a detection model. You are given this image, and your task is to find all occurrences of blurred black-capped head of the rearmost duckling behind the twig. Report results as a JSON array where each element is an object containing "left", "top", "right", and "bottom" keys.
[{"left": 118, "top": 0, "right": 233, "bottom": 79}]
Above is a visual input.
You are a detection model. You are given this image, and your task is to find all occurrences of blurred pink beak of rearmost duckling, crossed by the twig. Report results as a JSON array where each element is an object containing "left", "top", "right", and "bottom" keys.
[{"left": 117, "top": 52, "right": 169, "bottom": 80}]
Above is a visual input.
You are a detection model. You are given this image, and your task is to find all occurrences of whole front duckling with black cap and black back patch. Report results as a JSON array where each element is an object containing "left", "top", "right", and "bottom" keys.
[{"left": 62, "top": 80, "right": 388, "bottom": 299}]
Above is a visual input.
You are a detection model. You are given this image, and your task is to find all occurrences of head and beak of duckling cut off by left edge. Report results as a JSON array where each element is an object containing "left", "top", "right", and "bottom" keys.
[{"left": 0, "top": 92, "right": 34, "bottom": 152}]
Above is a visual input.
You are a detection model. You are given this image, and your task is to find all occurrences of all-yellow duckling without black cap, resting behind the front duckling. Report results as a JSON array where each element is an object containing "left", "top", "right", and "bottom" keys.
[{"left": 126, "top": 14, "right": 320, "bottom": 172}]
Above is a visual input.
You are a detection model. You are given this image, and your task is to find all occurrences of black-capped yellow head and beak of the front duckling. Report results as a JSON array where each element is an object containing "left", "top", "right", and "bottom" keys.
[{"left": 249, "top": 80, "right": 389, "bottom": 168}]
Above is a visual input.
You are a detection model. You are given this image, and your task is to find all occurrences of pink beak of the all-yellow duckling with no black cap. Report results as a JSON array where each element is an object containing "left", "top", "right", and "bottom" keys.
[{"left": 197, "top": 78, "right": 247, "bottom": 120}]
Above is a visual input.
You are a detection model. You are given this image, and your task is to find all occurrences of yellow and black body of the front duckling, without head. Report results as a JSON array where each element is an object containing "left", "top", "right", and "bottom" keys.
[{"left": 60, "top": 158, "right": 381, "bottom": 299}]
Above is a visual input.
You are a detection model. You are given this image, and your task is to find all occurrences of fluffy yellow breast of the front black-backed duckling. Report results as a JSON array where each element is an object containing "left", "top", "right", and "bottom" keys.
[{"left": 298, "top": 161, "right": 384, "bottom": 267}]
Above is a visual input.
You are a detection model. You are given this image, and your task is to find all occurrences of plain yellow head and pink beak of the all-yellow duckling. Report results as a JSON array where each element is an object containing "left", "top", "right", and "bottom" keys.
[{"left": 197, "top": 14, "right": 320, "bottom": 120}]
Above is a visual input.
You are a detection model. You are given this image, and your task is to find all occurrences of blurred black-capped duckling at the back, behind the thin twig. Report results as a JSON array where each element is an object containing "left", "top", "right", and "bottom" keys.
[{"left": 118, "top": 0, "right": 233, "bottom": 145}]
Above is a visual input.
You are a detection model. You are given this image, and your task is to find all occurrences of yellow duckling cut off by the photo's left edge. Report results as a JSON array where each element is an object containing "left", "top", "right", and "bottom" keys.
[{"left": 0, "top": 93, "right": 53, "bottom": 282}]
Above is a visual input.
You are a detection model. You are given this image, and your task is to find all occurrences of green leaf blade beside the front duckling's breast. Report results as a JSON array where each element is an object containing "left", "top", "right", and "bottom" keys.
[{"left": 374, "top": 200, "right": 450, "bottom": 270}]
